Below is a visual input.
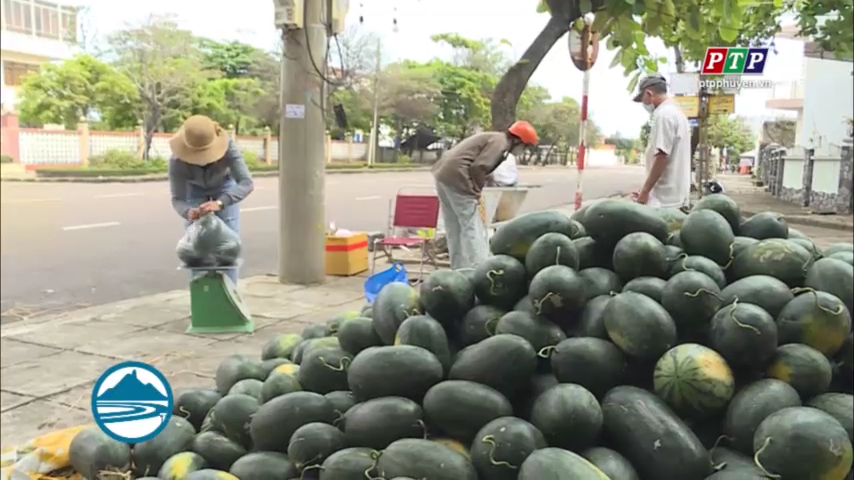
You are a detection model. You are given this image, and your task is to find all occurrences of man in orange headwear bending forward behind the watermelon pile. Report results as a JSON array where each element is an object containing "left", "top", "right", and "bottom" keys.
[{"left": 432, "top": 121, "right": 539, "bottom": 269}]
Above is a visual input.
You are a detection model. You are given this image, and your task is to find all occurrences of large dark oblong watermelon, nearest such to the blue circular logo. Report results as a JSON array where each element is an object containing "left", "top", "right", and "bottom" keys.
[{"left": 249, "top": 392, "right": 338, "bottom": 453}]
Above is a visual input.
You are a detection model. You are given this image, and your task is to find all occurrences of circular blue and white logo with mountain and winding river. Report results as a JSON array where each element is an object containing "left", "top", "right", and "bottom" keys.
[{"left": 92, "top": 362, "right": 173, "bottom": 443}]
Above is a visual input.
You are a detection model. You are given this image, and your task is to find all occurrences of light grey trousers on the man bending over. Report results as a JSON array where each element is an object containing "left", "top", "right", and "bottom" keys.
[{"left": 436, "top": 182, "right": 489, "bottom": 270}]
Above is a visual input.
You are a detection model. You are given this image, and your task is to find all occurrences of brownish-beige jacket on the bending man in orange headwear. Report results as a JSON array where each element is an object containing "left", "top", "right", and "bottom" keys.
[{"left": 432, "top": 132, "right": 510, "bottom": 197}]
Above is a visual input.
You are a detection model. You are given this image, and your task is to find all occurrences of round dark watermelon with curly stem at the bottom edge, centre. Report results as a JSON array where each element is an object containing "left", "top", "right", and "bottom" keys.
[{"left": 471, "top": 416, "right": 546, "bottom": 480}]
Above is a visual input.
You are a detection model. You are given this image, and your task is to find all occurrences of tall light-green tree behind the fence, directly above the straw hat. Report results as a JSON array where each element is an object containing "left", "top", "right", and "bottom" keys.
[{"left": 108, "top": 16, "right": 218, "bottom": 158}]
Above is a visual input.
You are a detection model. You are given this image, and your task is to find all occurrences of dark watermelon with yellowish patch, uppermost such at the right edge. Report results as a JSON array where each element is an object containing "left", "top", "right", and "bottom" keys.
[{"left": 777, "top": 290, "right": 851, "bottom": 357}]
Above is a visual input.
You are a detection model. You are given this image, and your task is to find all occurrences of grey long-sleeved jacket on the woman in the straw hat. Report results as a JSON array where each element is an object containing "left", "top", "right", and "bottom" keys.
[{"left": 169, "top": 140, "right": 255, "bottom": 218}]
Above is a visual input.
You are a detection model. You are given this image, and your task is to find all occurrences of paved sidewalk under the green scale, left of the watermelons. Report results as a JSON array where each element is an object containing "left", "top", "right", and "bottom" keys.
[{"left": 0, "top": 276, "right": 364, "bottom": 448}]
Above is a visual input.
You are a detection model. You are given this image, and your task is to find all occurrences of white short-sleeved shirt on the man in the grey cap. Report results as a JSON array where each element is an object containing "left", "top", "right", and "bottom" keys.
[{"left": 645, "top": 98, "right": 691, "bottom": 208}]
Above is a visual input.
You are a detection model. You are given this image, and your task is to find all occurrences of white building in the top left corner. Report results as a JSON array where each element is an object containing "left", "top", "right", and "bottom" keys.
[{"left": 0, "top": 0, "right": 78, "bottom": 109}]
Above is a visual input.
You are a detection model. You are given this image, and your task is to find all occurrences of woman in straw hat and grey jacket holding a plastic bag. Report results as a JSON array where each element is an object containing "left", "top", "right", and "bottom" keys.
[{"left": 169, "top": 115, "right": 255, "bottom": 283}]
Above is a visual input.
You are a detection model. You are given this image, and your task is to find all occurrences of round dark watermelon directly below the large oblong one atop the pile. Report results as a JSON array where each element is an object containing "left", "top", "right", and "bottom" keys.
[{"left": 613, "top": 232, "right": 667, "bottom": 281}]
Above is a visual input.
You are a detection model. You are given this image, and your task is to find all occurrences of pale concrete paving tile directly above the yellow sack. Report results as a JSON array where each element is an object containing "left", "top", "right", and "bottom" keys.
[{"left": 0, "top": 400, "right": 94, "bottom": 449}]
